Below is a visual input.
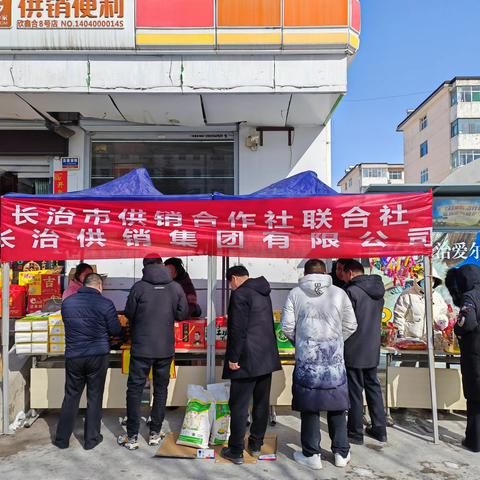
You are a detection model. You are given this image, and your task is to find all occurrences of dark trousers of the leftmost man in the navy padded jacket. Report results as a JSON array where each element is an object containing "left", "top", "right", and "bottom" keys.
[{"left": 55, "top": 355, "right": 108, "bottom": 448}]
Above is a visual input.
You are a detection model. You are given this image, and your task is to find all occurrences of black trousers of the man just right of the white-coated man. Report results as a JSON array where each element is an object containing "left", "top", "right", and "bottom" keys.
[{"left": 347, "top": 367, "right": 387, "bottom": 440}]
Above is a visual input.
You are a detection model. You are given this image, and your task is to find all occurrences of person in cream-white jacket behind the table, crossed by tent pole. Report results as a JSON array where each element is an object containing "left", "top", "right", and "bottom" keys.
[{"left": 393, "top": 271, "right": 449, "bottom": 341}]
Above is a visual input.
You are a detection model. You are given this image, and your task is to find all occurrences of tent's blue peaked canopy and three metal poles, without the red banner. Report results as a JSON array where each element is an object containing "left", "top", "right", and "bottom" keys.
[{"left": 2, "top": 169, "right": 439, "bottom": 443}]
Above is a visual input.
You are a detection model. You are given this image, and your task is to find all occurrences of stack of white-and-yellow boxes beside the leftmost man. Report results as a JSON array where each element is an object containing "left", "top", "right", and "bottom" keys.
[{"left": 15, "top": 313, "right": 48, "bottom": 355}]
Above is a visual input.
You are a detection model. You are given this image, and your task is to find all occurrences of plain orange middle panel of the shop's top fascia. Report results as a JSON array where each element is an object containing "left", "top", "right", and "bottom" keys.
[{"left": 218, "top": 0, "right": 281, "bottom": 28}]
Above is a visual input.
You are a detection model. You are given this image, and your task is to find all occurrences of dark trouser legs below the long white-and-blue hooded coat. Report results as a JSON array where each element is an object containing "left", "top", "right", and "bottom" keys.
[{"left": 300, "top": 410, "right": 350, "bottom": 458}]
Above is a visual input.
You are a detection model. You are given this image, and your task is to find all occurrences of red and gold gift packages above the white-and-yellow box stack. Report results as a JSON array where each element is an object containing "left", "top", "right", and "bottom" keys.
[{"left": 18, "top": 270, "right": 62, "bottom": 313}]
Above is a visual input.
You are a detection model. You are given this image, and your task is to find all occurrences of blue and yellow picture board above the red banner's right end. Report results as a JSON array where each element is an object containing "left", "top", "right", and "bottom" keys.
[{"left": 433, "top": 197, "right": 480, "bottom": 228}]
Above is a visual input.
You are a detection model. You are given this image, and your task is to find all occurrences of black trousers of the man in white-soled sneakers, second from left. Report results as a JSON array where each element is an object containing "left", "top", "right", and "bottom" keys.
[{"left": 127, "top": 357, "right": 173, "bottom": 437}]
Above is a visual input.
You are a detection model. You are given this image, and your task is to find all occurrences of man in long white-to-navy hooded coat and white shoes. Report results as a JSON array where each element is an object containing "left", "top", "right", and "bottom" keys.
[{"left": 282, "top": 260, "right": 357, "bottom": 470}]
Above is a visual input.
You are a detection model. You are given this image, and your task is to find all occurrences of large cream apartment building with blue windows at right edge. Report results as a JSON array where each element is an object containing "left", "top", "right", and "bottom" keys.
[{"left": 398, "top": 77, "right": 480, "bottom": 183}]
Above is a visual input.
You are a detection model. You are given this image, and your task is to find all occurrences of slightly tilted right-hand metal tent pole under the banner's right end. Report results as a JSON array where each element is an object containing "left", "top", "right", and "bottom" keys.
[{"left": 423, "top": 257, "right": 440, "bottom": 445}]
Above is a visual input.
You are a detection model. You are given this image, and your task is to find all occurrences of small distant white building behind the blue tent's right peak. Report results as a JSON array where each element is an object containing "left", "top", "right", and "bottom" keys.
[{"left": 337, "top": 163, "right": 404, "bottom": 193}]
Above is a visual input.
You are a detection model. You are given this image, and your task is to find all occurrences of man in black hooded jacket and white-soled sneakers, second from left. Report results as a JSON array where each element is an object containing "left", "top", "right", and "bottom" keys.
[{"left": 118, "top": 256, "right": 188, "bottom": 450}]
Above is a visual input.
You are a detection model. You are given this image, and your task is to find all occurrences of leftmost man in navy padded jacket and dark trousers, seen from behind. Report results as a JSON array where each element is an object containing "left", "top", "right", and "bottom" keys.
[{"left": 54, "top": 273, "right": 122, "bottom": 450}]
